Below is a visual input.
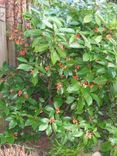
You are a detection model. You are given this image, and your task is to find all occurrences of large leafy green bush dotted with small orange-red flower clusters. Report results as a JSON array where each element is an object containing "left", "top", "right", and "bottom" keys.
[{"left": 0, "top": 0, "right": 117, "bottom": 154}]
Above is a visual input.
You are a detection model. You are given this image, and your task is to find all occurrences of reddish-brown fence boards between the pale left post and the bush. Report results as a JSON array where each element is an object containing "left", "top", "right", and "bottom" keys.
[{"left": 6, "top": 0, "right": 26, "bottom": 66}]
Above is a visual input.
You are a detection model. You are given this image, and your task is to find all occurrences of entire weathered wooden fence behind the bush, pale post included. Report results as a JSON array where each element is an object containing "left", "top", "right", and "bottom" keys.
[{"left": 0, "top": 0, "right": 29, "bottom": 67}]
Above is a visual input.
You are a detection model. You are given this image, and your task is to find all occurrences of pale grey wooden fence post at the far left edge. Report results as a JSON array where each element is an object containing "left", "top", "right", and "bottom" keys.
[{"left": 0, "top": 4, "right": 7, "bottom": 67}]
